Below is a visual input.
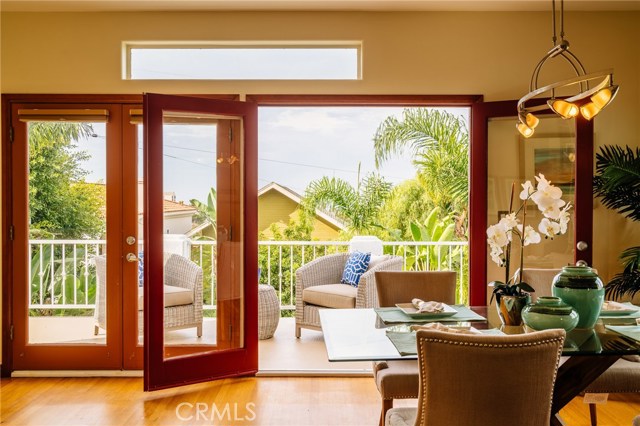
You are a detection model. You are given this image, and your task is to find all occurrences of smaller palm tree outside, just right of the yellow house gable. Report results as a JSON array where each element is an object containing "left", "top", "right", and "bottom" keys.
[{"left": 303, "top": 165, "right": 391, "bottom": 235}]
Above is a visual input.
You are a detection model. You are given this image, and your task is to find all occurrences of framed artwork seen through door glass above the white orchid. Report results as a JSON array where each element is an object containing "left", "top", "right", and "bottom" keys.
[{"left": 523, "top": 136, "right": 576, "bottom": 194}]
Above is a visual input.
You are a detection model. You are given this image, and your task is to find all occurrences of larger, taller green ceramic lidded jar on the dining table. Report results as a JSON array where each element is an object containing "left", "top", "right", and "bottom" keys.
[{"left": 551, "top": 266, "right": 604, "bottom": 328}]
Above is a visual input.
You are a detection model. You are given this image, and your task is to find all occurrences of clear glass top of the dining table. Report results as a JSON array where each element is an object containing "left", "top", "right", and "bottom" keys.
[{"left": 320, "top": 306, "right": 640, "bottom": 361}]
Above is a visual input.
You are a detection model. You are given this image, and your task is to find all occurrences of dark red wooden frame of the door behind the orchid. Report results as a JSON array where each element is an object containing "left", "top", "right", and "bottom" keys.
[{"left": 469, "top": 100, "right": 594, "bottom": 306}]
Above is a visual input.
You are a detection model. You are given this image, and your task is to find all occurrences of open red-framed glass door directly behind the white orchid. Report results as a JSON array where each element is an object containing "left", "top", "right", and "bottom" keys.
[{"left": 469, "top": 100, "right": 594, "bottom": 305}]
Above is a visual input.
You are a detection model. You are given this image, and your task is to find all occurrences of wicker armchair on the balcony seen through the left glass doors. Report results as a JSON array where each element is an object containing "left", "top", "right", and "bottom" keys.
[{"left": 94, "top": 254, "right": 203, "bottom": 337}]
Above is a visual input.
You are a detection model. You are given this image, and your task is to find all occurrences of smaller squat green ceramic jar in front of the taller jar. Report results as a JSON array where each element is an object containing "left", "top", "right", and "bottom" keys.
[{"left": 522, "top": 296, "right": 579, "bottom": 331}]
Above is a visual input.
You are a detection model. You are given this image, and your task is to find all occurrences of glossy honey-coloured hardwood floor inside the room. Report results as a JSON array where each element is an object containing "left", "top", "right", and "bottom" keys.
[{"left": 0, "top": 377, "right": 640, "bottom": 426}]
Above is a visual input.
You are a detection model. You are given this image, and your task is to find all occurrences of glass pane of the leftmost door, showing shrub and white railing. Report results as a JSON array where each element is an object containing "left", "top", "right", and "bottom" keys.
[{"left": 27, "top": 121, "right": 107, "bottom": 345}]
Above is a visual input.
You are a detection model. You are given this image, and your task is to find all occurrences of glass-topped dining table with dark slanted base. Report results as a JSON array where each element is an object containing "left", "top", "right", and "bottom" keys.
[{"left": 319, "top": 305, "right": 640, "bottom": 426}]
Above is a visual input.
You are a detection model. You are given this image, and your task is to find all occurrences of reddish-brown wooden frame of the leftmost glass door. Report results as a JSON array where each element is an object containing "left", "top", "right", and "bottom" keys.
[{"left": 2, "top": 95, "right": 134, "bottom": 375}]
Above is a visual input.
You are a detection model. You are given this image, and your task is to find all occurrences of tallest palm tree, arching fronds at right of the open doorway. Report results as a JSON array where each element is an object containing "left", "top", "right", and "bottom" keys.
[{"left": 373, "top": 108, "right": 469, "bottom": 221}]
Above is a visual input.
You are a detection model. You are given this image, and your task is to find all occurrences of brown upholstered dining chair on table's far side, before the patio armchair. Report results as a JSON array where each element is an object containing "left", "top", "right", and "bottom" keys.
[{"left": 373, "top": 271, "right": 456, "bottom": 424}]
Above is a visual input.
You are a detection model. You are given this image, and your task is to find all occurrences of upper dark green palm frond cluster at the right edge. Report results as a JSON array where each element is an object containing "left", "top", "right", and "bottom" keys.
[{"left": 593, "top": 145, "right": 640, "bottom": 220}]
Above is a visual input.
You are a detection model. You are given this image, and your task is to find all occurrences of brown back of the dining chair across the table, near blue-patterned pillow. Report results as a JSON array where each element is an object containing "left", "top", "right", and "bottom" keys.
[{"left": 376, "top": 271, "right": 456, "bottom": 307}]
